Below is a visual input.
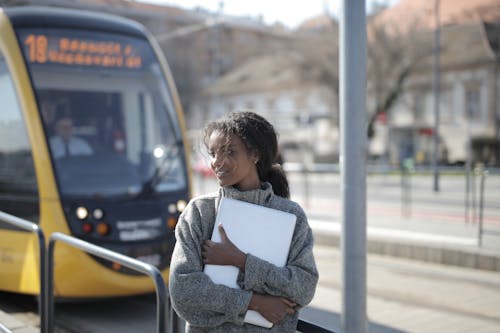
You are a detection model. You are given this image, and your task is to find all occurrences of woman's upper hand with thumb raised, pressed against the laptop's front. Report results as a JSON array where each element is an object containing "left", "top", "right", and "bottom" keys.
[{"left": 201, "top": 224, "right": 247, "bottom": 271}]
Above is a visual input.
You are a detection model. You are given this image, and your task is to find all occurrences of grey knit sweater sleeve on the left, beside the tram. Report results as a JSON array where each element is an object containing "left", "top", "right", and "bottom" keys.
[{"left": 169, "top": 198, "right": 252, "bottom": 327}]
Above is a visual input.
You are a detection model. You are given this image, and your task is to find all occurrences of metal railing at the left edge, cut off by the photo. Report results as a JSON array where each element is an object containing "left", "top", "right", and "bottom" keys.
[{"left": 0, "top": 211, "right": 49, "bottom": 333}]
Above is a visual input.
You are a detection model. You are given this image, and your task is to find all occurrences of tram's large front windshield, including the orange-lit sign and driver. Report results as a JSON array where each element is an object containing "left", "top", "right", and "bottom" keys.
[{"left": 18, "top": 29, "right": 186, "bottom": 197}]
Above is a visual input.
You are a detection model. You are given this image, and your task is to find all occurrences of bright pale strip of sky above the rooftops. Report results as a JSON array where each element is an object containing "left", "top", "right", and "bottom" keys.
[{"left": 141, "top": 0, "right": 399, "bottom": 28}]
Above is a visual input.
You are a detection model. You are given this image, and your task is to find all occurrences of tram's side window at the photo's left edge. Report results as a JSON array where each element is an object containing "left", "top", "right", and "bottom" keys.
[{"left": 0, "top": 51, "right": 39, "bottom": 223}]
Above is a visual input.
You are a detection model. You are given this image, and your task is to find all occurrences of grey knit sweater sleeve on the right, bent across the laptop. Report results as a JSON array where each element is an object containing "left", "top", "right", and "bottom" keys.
[{"left": 238, "top": 212, "right": 318, "bottom": 307}]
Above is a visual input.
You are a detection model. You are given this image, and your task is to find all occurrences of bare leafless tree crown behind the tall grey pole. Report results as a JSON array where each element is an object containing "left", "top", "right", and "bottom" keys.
[{"left": 296, "top": 9, "right": 432, "bottom": 138}]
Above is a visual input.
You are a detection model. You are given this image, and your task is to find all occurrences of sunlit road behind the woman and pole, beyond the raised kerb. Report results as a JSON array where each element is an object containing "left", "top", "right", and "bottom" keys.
[{"left": 198, "top": 172, "right": 500, "bottom": 254}]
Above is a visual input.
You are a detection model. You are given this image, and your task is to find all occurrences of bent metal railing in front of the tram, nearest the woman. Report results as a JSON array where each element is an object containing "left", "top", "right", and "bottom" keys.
[{"left": 44, "top": 232, "right": 170, "bottom": 333}]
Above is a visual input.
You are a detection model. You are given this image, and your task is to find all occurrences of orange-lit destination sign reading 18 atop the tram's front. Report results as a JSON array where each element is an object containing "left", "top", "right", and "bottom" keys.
[{"left": 20, "top": 30, "right": 148, "bottom": 70}]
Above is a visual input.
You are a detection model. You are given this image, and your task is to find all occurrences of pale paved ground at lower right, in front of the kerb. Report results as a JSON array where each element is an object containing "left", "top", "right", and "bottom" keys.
[{"left": 301, "top": 245, "right": 500, "bottom": 333}]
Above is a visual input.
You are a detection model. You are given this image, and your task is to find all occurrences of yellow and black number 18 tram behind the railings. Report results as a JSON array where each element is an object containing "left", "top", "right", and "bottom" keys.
[{"left": 0, "top": 7, "right": 191, "bottom": 298}]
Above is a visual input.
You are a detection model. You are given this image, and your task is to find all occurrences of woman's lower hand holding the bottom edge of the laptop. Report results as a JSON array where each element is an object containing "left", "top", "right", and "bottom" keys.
[{"left": 248, "top": 293, "right": 297, "bottom": 324}]
